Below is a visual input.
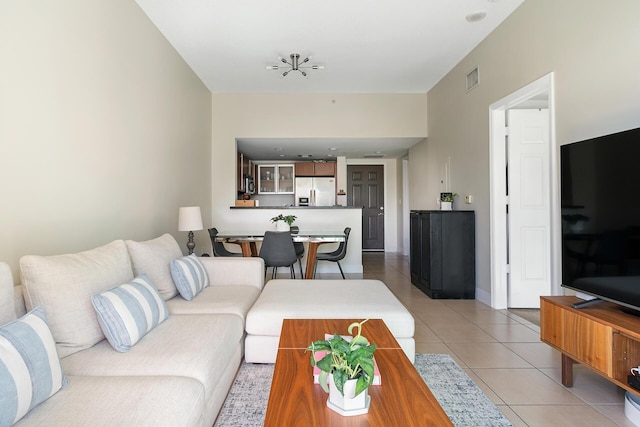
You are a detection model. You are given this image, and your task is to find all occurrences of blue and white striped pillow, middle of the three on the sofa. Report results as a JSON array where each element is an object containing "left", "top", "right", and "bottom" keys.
[{"left": 91, "top": 274, "right": 169, "bottom": 353}]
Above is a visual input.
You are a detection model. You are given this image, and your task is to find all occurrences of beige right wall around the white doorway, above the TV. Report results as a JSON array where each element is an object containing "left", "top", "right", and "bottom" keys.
[{"left": 410, "top": 0, "right": 640, "bottom": 300}]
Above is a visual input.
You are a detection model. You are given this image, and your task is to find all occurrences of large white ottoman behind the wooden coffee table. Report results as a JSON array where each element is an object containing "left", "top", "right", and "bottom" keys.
[{"left": 244, "top": 280, "right": 415, "bottom": 363}]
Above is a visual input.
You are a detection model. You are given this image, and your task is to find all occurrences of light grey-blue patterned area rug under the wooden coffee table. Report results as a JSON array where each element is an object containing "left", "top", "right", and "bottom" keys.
[{"left": 215, "top": 354, "right": 512, "bottom": 427}]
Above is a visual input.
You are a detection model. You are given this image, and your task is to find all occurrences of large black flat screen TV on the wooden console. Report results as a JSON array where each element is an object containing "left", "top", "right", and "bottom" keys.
[{"left": 560, "top": 128, "right": 640, "bottom": 313}]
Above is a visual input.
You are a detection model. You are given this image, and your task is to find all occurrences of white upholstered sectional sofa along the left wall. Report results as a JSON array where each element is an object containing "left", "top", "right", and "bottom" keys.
[{"left": 0, "top": 234, "right": 264, "bottom": 426}]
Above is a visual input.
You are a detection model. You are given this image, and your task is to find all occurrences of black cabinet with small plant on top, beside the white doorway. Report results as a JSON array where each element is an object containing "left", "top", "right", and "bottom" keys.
[{"left": 410, "top": 211, "right": 476, "bottom": 299}]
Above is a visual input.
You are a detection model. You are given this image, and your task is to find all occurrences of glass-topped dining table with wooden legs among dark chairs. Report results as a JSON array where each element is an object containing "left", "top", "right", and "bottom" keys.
[{"left": 217, "top": 230, "right": 346, "bottom": 279}]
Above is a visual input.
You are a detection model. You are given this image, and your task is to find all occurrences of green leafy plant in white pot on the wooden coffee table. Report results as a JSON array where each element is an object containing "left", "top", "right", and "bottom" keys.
[{"left": 307, "top": 319, "right": 376, "bottom": 416}]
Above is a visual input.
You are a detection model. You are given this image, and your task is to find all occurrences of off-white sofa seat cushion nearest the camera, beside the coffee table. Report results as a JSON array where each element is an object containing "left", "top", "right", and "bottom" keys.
[{"left": 15, "top": 376, "right": 205, "bottom": 427}]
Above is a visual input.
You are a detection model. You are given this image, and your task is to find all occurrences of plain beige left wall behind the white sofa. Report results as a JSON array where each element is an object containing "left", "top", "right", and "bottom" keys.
[{"left": 0, "top": 0, "right": 211, "bottom": 279}]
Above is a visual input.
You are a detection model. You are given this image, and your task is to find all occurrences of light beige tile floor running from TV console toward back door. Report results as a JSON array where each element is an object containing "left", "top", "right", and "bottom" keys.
[{"left": 319, "top": 252, "right": 633, "bottom": 427}]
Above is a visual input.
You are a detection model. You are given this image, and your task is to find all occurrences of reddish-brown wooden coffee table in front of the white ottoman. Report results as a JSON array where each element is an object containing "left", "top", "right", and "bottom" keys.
[{"left": 264, "top": 319, "right": 453, "bottom": 427}]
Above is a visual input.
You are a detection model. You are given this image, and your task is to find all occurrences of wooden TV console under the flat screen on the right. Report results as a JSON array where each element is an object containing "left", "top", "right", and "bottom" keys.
[{"left": 540, "top": 296, "right": 640, "bottom": 394}]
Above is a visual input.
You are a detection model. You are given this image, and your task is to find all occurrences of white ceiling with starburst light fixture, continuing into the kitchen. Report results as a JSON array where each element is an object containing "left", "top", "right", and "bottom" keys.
[{"left": 136, "top": 0, "right": 524, "bottom": 157}]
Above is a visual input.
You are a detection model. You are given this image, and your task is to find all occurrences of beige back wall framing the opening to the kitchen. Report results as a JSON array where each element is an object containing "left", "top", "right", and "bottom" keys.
[{"left": 211, "top": 94, "right": 427, "bottom": 251}]
